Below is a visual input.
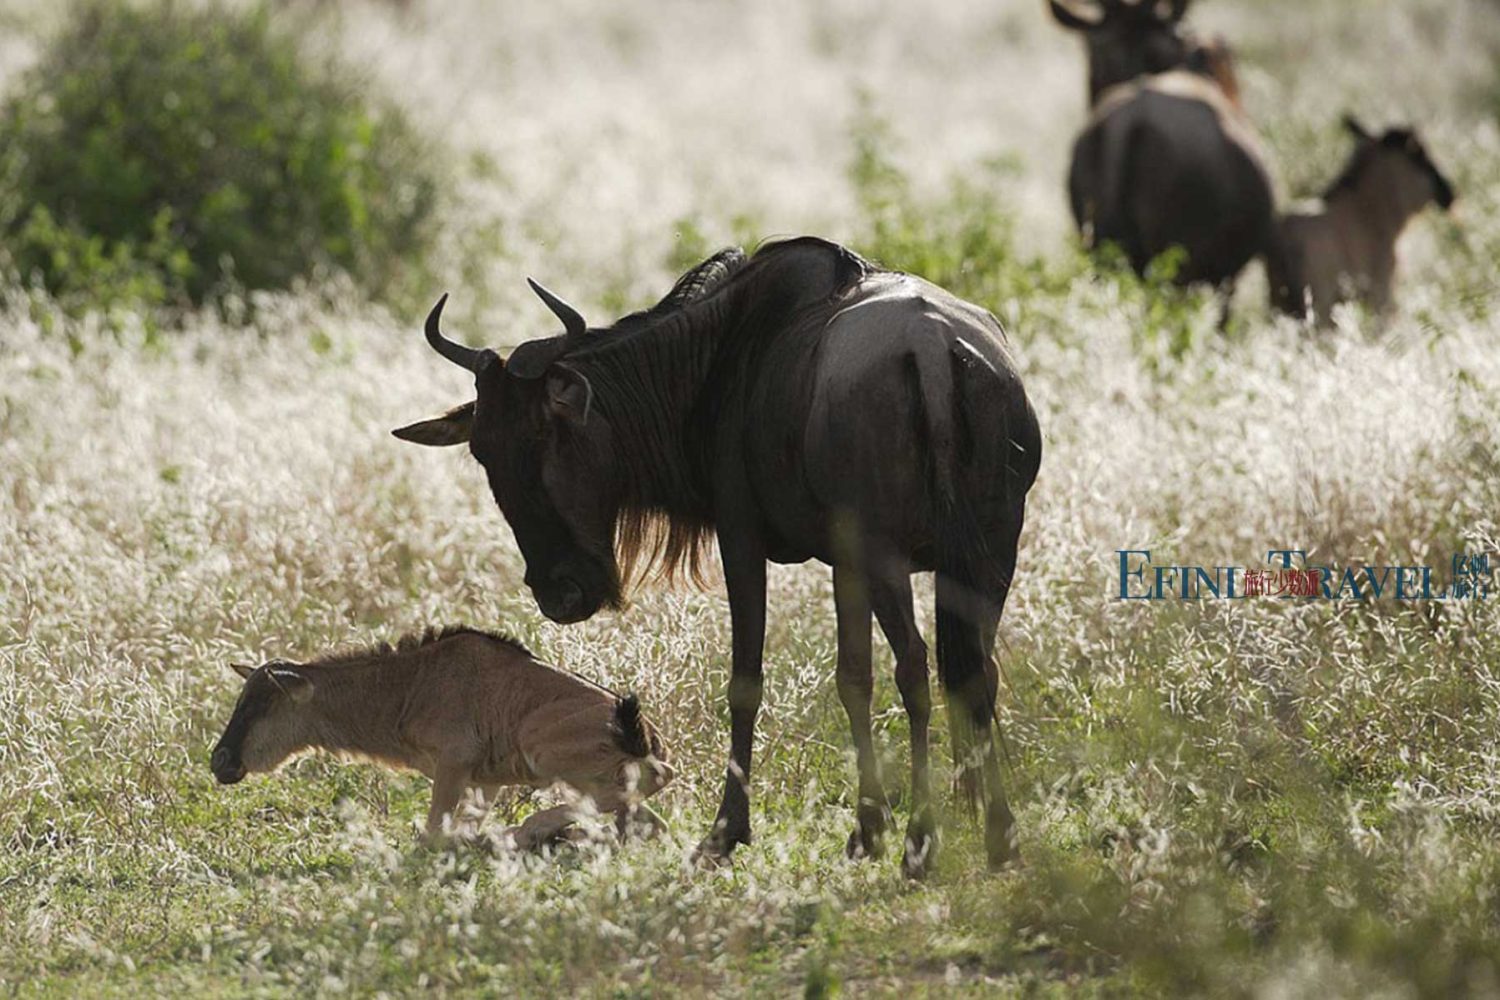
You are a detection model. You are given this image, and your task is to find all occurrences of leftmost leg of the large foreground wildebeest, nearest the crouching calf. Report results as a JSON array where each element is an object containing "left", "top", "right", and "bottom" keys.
[{"left": 698, "top": 523, "right": 765, "bottom": 861}]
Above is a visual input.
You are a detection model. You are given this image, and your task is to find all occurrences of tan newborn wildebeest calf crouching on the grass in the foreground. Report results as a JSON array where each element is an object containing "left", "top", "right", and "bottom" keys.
[{"left": 212, "top": 628, "right": 672, "bottom": 847}]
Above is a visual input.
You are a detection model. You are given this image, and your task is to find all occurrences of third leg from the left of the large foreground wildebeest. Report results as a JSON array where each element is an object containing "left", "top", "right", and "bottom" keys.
[{"left": 870, "top": 568, "right": 938, "bottom": 879}]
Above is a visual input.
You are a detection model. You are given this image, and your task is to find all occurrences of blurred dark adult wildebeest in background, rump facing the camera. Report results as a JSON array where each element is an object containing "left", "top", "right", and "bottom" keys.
[{"left": 1050, "top": 0, "right": 1274, "bottom": 301}]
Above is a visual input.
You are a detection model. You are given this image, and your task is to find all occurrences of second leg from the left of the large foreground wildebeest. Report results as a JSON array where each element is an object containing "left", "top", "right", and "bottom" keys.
[{"left": 834, "top": 565, "right": 890, "bottom": 858}]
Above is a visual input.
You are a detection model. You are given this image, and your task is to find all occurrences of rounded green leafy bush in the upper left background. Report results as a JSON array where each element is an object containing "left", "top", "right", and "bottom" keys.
[{"left": 0, "top": 0, "right": 438, "bottom": 313}]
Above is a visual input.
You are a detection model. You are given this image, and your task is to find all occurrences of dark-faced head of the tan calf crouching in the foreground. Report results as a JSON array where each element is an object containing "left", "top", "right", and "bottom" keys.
[{"left": 209, "top": 661, "right": 312, "bottom": 784}]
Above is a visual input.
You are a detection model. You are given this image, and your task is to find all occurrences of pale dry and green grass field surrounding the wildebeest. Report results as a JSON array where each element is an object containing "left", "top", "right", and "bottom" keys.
[{"left": 0, "top": 0, "right": 1500, "bottom": 997}]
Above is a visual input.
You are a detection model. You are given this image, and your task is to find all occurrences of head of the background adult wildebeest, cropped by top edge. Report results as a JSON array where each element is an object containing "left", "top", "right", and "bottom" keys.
[{"left": 1049, "top": 0, "right": 1194, "bottom": 105}]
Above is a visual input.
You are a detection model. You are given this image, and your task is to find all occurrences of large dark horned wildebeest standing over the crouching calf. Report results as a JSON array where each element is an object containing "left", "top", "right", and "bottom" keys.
[{"left": 396, "top": 238, "right": 1041, "bottom": 876}]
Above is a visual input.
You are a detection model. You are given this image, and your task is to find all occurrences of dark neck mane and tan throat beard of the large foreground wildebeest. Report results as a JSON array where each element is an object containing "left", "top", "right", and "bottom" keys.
[{"left": 566, "top": 237, "right": 879, "bottom": 589}]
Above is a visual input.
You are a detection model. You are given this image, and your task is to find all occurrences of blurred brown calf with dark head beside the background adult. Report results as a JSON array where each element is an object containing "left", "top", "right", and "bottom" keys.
[{"left": 1266, "top": 117, "right": 1454, "bottom": 325}]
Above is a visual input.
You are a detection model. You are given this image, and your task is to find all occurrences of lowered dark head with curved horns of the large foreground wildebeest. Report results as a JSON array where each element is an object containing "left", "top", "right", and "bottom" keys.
[{"left": 392, "top": 282, "right": 623, "bottom": 622}]
